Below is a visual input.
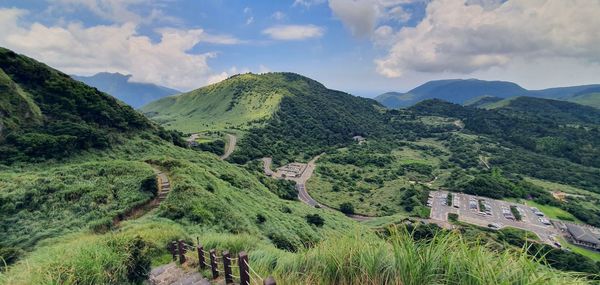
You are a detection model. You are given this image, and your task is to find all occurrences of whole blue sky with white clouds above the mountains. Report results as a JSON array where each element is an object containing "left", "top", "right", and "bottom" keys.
[{"left": 0, "top": 0, "right": 600, "bottom": 97}]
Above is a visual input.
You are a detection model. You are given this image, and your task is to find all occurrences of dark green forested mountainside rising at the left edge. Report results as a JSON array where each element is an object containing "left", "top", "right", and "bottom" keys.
[{"left": 0, "top": 48, "right": 180, "bottom": 162}]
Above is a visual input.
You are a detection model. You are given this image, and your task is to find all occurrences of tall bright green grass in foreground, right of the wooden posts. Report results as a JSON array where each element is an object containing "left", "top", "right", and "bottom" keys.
[{"left": 251, "top": 230, "right": 589, "bottom": 285}]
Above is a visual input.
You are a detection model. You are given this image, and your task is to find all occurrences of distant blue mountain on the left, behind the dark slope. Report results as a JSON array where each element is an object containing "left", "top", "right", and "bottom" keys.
[{"left": 71, "top": 72, "right": 181, "bottom": 109}]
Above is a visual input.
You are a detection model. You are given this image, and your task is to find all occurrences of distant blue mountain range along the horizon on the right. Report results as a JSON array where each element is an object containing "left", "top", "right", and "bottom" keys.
[{"left": 375, "top": 79, "right": 600, "bottom": 108}]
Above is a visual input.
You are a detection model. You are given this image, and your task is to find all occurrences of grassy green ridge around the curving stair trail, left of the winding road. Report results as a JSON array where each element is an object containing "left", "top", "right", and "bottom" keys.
[{"left": 0, "top": 137, "right": 358, "bottom": 284}]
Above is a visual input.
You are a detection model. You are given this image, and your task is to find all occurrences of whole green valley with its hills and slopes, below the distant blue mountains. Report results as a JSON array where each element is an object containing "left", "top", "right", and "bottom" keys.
[{"left": 0, "top": 47, "right": 600, "bottom": 284}]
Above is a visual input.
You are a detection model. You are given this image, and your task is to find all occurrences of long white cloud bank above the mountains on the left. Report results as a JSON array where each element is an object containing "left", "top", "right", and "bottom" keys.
[{"left": 0, "top": 9, "right": 240, "bottom": 90}]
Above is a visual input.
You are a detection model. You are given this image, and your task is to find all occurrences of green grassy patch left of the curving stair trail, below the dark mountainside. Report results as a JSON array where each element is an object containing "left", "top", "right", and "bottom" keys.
[{"left": 0, "top": 160, "right": 156, "bottom": 248}]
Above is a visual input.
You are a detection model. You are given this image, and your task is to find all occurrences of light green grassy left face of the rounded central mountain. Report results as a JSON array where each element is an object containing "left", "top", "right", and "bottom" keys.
[{"left": 142, "top": 74, "right": 290, "bottom": 132}]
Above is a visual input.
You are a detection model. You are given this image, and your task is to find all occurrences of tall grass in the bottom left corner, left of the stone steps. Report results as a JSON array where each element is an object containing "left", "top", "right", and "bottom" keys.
[{"left": 0, "top": 219, "right": 187, "bottom": 285}]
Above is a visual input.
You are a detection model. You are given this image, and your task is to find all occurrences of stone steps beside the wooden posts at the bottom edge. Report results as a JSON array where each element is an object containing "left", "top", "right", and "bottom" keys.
[{"left": 148, "top": 263, "right": 210, "bottom": 285}]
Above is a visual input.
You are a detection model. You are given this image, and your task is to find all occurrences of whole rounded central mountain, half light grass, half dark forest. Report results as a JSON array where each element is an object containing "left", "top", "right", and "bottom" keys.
[{"left": 142, "top": 73, "right": 392, "bottom": 162}]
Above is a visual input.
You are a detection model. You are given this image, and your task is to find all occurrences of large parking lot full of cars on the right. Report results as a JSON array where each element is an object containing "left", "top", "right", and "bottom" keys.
[{"left": 429, "top": 191, "right": 559, "bottom": 246}]
